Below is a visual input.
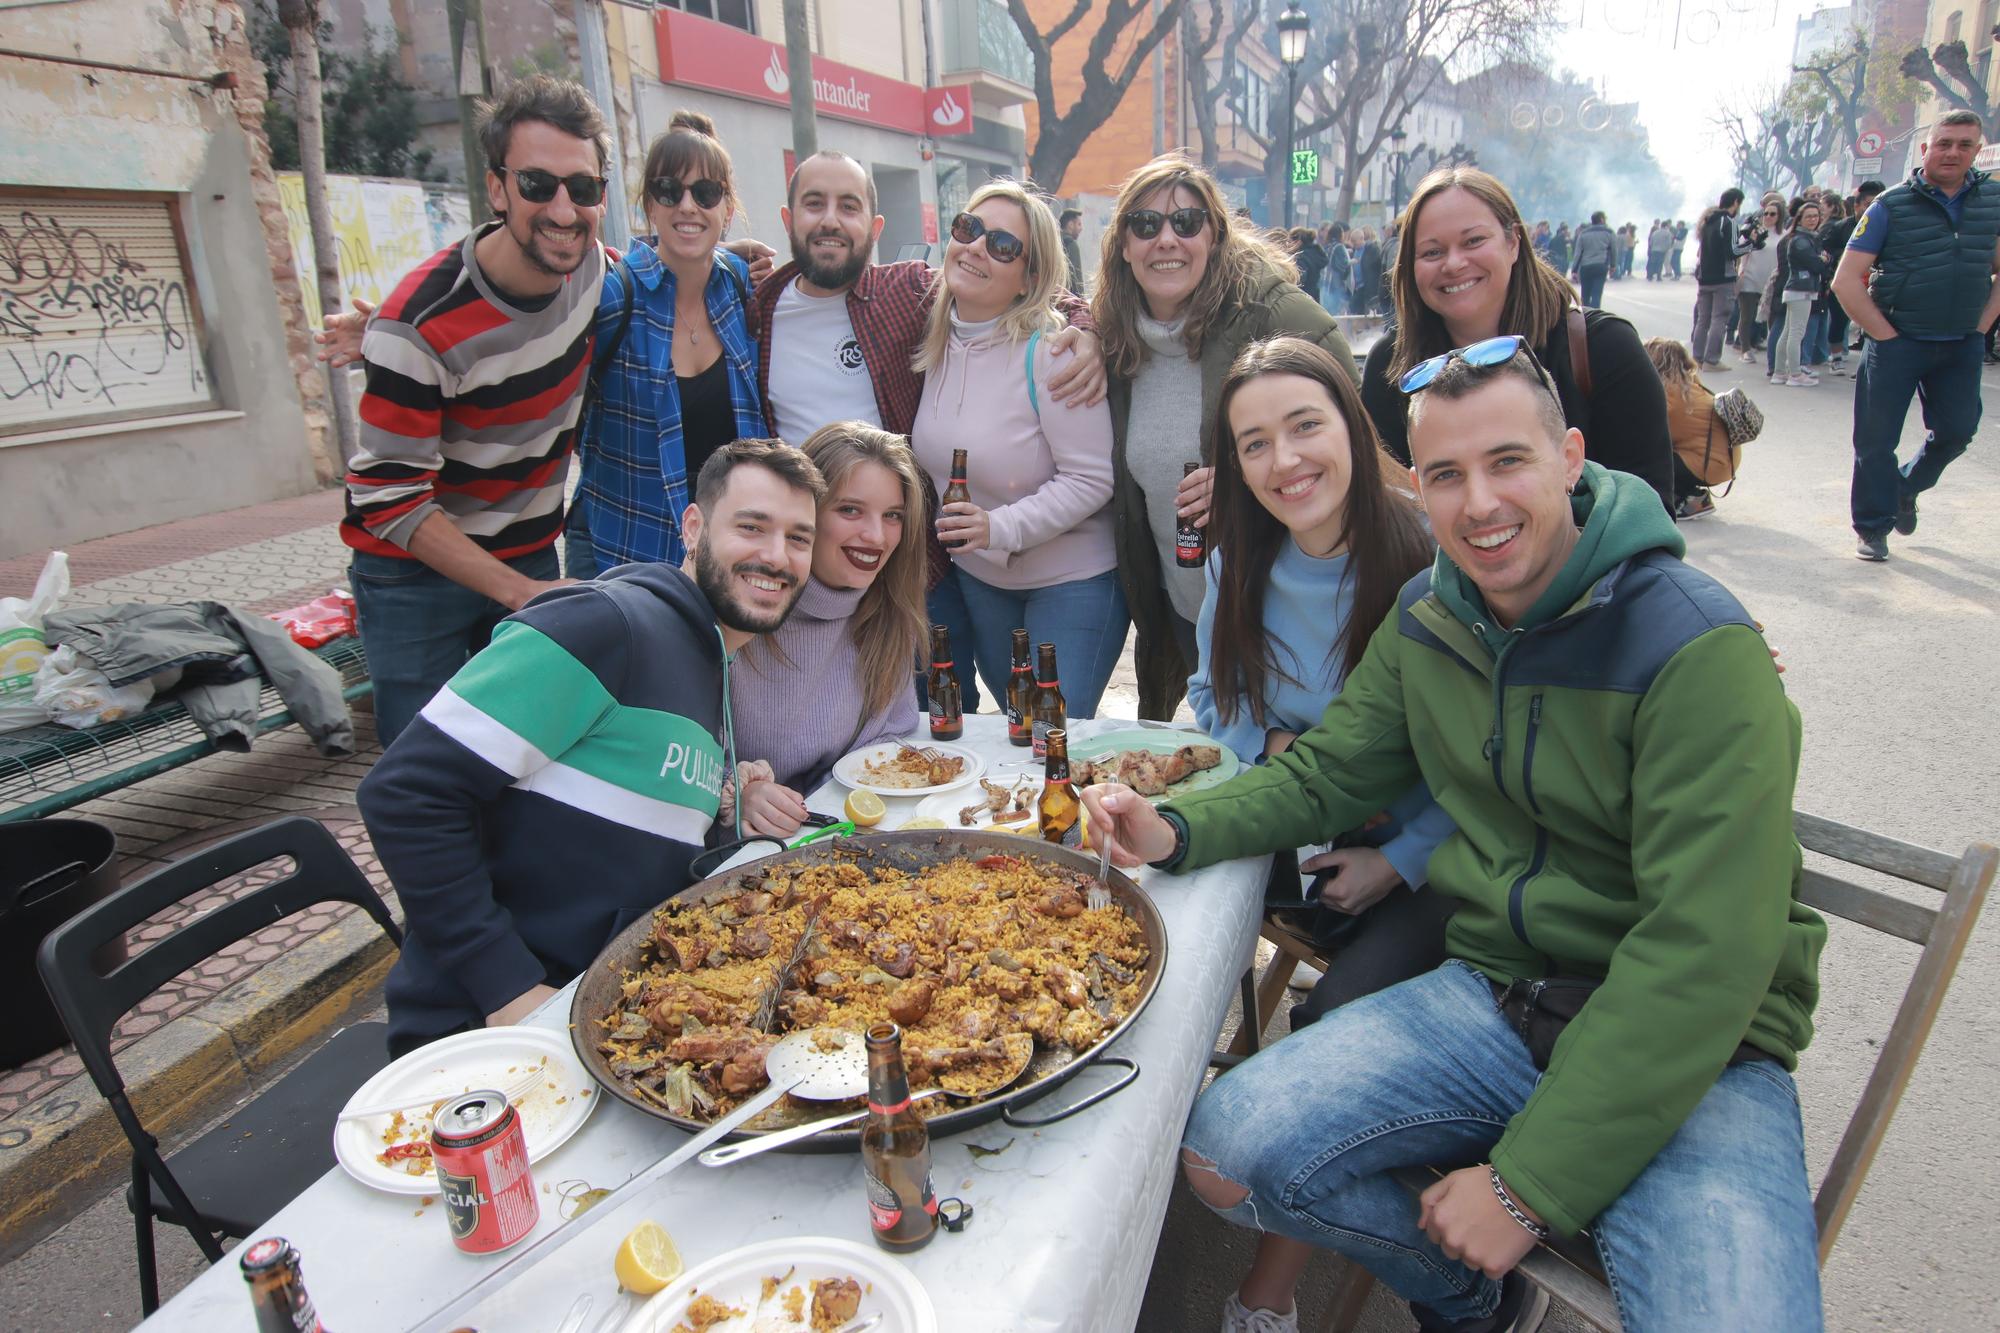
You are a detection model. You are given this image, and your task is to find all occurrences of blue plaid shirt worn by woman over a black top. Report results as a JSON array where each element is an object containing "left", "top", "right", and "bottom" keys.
[{"left": 576, "top": 242, "right": 766, "bottom": 574}]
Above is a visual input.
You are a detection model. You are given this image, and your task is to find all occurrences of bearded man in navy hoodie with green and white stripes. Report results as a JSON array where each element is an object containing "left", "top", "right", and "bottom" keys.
[{"left": 358, "top": 440, "right": 826, "bottom": 1055}]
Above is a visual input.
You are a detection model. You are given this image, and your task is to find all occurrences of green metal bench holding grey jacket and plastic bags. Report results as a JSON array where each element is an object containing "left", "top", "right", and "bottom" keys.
[{"left": 0, "top": 634, "right": 374, "bottom": 823}]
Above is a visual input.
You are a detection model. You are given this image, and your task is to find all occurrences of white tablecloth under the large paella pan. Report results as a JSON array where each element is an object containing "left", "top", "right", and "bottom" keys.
[{"left": 146, "top": 715, "right": 1266, "bottom": 1333}]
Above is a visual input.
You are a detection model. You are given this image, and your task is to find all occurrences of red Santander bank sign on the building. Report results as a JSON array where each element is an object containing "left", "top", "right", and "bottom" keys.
[{"left": 654, "top": 10, "right": 972, "bottom": 134}]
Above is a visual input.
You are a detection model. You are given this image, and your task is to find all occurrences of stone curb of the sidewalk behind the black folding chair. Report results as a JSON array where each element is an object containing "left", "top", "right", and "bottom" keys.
[{"left": 0, "top": 911, "right": 396, "bottom": 1263}]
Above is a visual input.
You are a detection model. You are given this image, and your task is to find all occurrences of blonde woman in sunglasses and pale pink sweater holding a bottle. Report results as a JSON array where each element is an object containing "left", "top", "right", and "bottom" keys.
[{"left": 910, "top": 180, "right": 1128, "bottom": 717}]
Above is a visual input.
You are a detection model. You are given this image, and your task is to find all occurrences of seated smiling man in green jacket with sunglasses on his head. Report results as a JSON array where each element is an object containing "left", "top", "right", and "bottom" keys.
[{"left": 1084, "top": 340, "right": 1826, "bottom": 1333}]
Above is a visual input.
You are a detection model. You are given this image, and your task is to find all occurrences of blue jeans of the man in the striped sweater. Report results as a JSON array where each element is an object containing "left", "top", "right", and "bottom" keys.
[{"left": 348, "top": 546, "right": 562, "bottom": 749}]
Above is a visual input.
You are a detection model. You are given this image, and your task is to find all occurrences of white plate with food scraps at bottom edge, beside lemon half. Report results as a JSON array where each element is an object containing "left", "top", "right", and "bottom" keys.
[{"left": 622, "top": 1232, "right": 938, "bottom": 1333}]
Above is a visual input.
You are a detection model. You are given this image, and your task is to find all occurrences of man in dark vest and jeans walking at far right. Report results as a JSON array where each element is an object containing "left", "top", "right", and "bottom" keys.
[{"left": 1834, "top": 110, "right": 2000, "bottom": 560}]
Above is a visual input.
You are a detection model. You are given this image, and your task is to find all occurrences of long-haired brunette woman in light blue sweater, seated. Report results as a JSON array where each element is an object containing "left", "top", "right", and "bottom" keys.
[{"left": 1188, "top": 338, "right": 1452, "bottom": 1027}]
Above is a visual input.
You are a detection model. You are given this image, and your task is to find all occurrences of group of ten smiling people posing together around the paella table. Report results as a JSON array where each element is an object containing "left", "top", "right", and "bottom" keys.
[{"left": 334, "top": 78, "right": 1824, "bottom": 1333}]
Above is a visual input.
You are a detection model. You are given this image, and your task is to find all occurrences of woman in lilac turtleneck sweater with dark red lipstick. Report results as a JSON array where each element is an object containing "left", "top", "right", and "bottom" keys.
[{"left": 732, "top": 420, "right": 926, "bottom": 837}]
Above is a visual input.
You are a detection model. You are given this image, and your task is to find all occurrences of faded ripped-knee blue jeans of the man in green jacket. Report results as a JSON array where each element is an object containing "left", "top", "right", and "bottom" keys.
[{"left": 1184, "top": 961, "right": 1822, "bottom": 1333}]
